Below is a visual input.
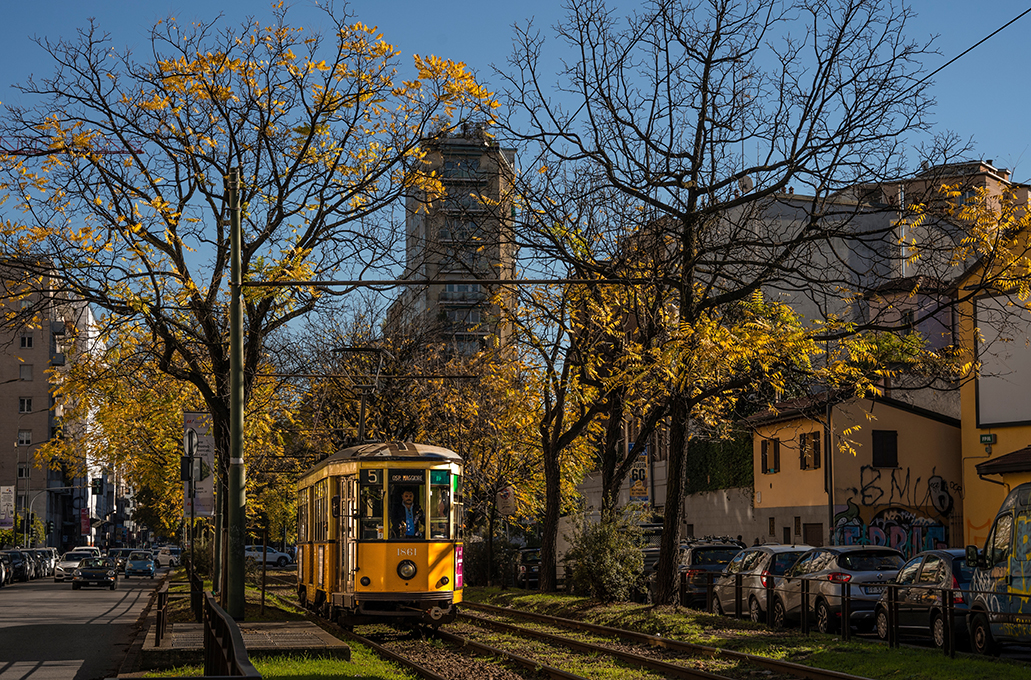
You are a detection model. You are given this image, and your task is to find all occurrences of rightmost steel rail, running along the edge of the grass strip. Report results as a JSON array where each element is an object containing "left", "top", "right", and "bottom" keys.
[{"left": 462, "top": 602, "right": 869, "bottom": 680}]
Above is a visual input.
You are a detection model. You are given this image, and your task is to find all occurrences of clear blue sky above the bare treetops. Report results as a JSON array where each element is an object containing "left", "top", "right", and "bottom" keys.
[{"left": 0, "top": 0, "right": 1031, "bottom": 181}]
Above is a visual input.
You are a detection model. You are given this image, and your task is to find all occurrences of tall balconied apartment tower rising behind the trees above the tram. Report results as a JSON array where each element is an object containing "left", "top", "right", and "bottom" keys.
[{"left": 386, "top": 126, "right": 517, "bottom": 354}]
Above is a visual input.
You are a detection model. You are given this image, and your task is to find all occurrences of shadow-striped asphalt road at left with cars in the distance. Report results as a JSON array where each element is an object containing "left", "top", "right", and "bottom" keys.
[{"left": 0, "top": 570, "right": 159, "bottom": 680}]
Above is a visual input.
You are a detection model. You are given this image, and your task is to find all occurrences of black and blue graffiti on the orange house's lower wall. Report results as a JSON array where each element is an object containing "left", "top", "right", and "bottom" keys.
[{"left": 834, "top": 466, "right": 962, "bottom": 556}]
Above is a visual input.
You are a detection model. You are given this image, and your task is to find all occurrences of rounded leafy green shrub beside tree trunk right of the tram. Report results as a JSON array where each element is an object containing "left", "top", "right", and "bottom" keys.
[{"left": 565, "top": 511, "right": 644, "bottom": 602}]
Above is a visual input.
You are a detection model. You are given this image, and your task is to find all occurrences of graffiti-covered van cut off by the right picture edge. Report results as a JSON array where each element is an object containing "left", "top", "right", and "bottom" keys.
[{"left": 966, "top": 482, "right": 1031, "bottom": 654}]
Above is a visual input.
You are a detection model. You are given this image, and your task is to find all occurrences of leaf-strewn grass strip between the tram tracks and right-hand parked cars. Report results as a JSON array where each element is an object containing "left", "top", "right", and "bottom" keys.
[{"left": 463, "top": 588, "right": 1031, "bottom": 680}]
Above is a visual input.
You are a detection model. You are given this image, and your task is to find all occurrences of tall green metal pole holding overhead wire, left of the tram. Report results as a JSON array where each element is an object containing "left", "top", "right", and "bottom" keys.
[{"left": 226, "top": 167, "right": 246, "bottom": 621}]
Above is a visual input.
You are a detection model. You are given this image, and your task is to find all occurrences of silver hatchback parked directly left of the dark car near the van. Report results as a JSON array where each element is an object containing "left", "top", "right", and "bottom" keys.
[{"left": 772, "top": 545, "right": 904, "bottom": 633}]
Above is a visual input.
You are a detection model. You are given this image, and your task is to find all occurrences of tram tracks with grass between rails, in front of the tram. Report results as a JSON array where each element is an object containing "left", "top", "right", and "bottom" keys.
[{"left": 334, "top": 603, "right": 882, "bottom": 680}]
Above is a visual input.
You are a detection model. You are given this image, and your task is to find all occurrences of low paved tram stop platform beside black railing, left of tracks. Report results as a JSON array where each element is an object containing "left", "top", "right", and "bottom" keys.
[{"left": 137, "top": 621, "right": 351, "bottom": 671}]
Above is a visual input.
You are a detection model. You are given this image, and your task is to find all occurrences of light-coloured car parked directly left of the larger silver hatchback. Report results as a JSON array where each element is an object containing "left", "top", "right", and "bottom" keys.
[{"left": 712, "top": 544, "right": 811, "bottom": 622}]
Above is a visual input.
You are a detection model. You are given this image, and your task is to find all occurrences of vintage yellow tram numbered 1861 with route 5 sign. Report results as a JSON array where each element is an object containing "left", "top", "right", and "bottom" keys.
[{"left": 297, "top": 442, "right": 463, "bottom": 625}]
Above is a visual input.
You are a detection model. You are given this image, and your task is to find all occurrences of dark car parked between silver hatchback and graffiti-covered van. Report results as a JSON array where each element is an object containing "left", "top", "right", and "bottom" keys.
[{"left": 874, "top": 548, "right": 973, "bottom": 649}]
